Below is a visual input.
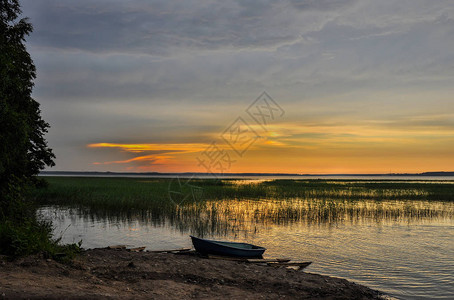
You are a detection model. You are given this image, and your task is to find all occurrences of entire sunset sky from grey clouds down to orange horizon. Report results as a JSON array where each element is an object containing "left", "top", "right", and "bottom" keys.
[{"left": 21, "top": 0, "right": 454, "bottom": 174}]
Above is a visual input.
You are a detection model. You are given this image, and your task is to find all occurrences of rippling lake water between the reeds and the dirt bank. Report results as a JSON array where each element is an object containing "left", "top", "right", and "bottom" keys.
[{"left": 39, "top": 199, "right": 454, "bottom": 299}]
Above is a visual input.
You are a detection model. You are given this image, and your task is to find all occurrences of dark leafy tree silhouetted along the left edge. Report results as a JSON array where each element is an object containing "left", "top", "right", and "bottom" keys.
[{"left": 0, "top": 0, "right": 55, "bottom": 218}]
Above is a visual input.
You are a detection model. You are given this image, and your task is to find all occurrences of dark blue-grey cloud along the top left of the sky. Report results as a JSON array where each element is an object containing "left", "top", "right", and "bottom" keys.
[{"left": 25, "top": 0, "right": 302, "bottom": 55}]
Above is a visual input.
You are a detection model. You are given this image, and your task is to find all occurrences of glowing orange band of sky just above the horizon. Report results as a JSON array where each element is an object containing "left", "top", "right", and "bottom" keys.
[{"left": 87, "top": 116, "right": 454, "bottom": 174}]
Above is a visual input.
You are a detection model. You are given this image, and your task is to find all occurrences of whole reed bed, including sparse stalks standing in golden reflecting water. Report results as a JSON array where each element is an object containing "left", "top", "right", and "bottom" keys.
[{"left": 30, "top": 177, "right": 454, "bottom": 236}]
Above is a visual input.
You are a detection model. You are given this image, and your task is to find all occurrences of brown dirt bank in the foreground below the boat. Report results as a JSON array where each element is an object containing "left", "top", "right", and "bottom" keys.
[{"left": 0, "top": 249, "right": 379, "bottom": 299}]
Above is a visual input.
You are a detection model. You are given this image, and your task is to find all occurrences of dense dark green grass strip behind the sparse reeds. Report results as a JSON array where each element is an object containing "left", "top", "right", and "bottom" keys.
[{"left": 29, "top": 177, "right": 454, "bottom": 211}]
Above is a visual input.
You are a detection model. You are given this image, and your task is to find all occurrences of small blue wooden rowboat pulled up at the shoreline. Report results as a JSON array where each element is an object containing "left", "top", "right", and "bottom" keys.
[{"left": 190, "top": 235, "right": 266, "bottom": 257}]
